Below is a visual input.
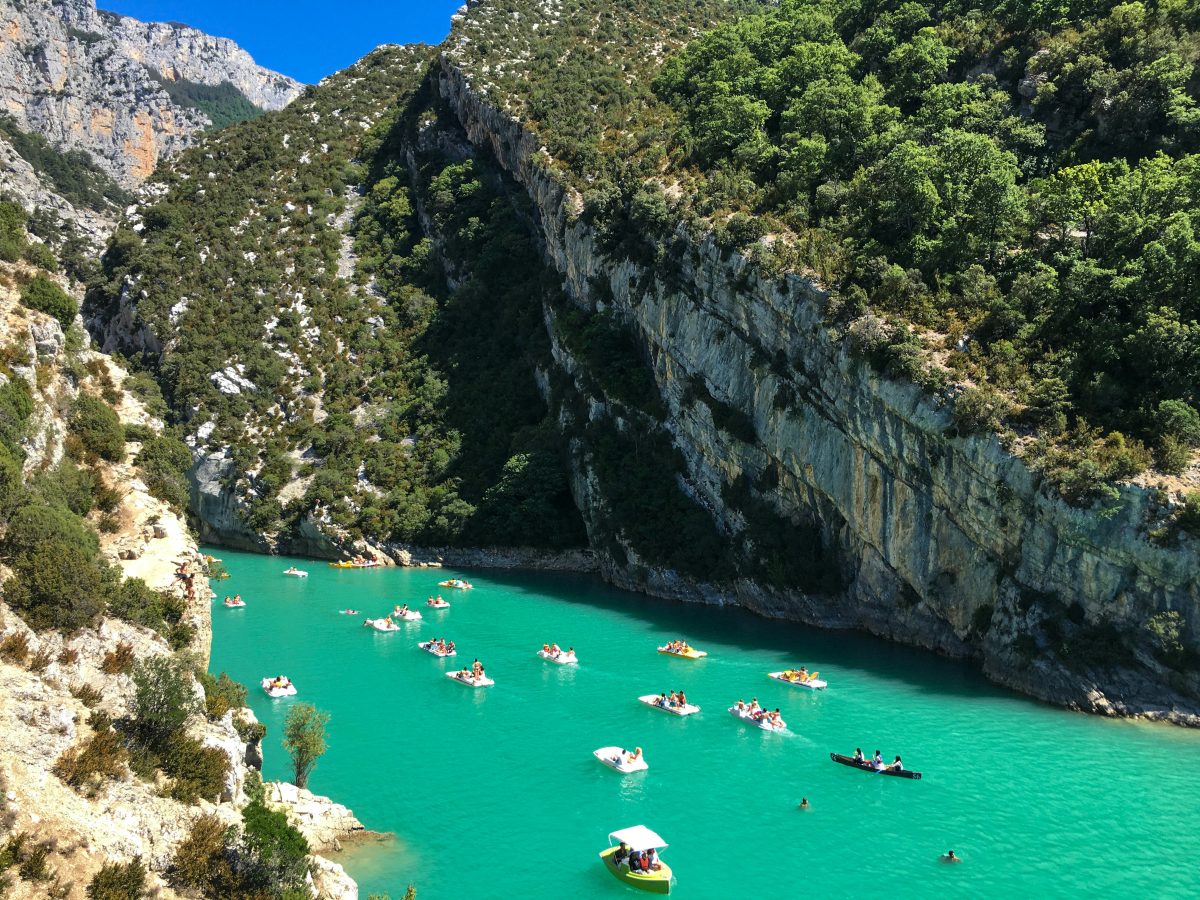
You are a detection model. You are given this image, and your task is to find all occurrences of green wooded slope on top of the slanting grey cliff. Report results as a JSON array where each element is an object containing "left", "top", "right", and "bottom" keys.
[{"left": 455, "top": 0, "right": 1200, "bottom": 504}]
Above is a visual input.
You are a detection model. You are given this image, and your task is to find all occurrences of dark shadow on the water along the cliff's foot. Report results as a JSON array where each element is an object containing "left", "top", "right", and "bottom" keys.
[{"left": 472, "top": 570, "right": 1008, "bottom": 702}]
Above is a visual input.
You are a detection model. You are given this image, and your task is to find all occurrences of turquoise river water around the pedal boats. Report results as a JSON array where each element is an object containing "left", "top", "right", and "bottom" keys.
[{"left": 212, "top": 551, "right": 1200, "bottom": 900}]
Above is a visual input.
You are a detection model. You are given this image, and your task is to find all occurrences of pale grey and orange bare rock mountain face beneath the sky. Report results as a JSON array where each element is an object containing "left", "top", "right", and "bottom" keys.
[{"left": 0, "top": 0, "right": 301, "bottom": 186}]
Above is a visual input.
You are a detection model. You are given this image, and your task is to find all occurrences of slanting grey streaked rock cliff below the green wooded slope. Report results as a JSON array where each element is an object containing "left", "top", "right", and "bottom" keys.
[{"left": 439, "top": 58, "right": 1200, "bottom": 724}]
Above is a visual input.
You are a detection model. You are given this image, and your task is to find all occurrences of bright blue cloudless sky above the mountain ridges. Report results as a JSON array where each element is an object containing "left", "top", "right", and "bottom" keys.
[{"left": 97, "top": 0, "right": 463, "bottom": 84}]
